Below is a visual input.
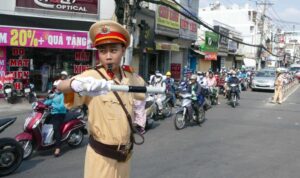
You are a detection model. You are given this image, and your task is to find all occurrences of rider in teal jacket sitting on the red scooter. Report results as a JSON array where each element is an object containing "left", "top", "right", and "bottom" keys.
[{"left": 44, "top": 81, "right": 67, "bottom": 157}]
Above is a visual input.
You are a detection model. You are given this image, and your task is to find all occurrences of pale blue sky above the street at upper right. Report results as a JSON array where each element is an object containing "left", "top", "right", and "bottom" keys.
[{"left": 199, "top": 0, "right": 300, "bottom": 31}]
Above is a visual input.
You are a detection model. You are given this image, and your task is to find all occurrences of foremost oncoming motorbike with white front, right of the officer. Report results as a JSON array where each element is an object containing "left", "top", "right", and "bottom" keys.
[{"left": 174, "top": 93, "right": 205, "bottom": 130}]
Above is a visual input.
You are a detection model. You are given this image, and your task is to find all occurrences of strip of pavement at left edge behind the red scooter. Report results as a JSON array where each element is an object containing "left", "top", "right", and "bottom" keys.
[{"left": 0, "top": 98, "right": 31, "bottom": 118}]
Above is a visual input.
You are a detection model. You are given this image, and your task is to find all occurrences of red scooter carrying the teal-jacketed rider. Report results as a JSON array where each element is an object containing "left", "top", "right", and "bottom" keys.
[{"left": 15, "top": 101, "right": 87, "bottom": 159}]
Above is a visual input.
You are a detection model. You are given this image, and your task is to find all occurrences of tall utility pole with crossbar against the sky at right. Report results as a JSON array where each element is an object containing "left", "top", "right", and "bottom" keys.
[{"left": 256, "top": 0, "right": 273, "bottom": 69}]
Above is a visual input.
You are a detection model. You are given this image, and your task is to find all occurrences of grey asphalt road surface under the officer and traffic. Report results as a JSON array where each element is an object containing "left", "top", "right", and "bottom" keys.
[{"left": 1, "top": 86, "right": 300, "bottom": 178}]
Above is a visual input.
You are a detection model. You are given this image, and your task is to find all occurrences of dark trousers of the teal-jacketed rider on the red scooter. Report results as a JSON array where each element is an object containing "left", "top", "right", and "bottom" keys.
[{"left": 50, "top": 114, "right": 66, "bottom": 148}]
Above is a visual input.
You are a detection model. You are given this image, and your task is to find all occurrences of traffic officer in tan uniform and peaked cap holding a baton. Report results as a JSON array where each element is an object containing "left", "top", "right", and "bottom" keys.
[{"left": 58, "top": 20, "right": 145, "bottom": 178}]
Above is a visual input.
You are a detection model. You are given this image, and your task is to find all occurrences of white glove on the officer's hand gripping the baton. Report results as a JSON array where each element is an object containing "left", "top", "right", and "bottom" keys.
[{"left": 71, "top": 77, "right": 113, "bottom": 96}]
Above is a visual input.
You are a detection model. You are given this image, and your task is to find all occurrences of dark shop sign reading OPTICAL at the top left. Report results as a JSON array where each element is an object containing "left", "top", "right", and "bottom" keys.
[{"left": 16, "top": 0, "right": 98, "bottom": 14}]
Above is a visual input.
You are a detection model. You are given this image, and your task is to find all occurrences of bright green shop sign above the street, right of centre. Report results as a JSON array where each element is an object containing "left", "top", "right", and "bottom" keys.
[{"left": 200, "top": 31, "right": 219, "bottom": 52}]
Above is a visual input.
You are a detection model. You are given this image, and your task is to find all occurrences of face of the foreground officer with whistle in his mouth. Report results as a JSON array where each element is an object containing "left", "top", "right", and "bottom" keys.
[{"left": 97, "top": 44, "right": 125, "bottom": 70}]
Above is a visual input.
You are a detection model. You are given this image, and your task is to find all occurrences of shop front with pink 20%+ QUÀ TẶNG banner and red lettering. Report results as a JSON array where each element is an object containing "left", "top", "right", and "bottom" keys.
[{"left": 0, "top": 26, "right": 94, "bottom": 91}]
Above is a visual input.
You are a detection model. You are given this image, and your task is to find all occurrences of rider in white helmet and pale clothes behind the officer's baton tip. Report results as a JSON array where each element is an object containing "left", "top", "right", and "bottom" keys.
[{"left": 150, "top": 72, "right": 166, "bottom": 115}]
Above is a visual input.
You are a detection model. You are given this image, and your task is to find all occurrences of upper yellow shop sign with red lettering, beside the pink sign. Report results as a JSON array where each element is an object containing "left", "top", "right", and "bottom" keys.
[{"left": 156, "top": 0, "right": 180, "bottom": 29}]
